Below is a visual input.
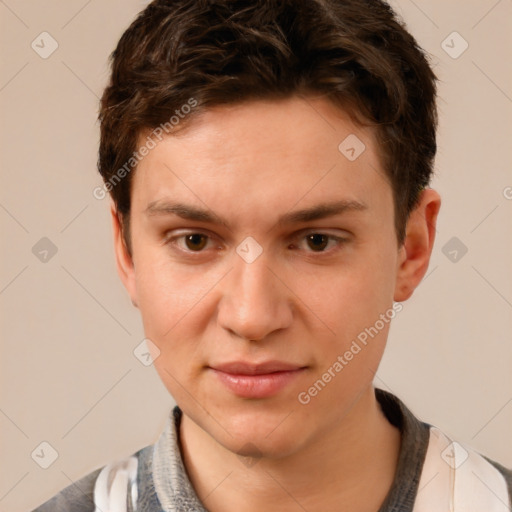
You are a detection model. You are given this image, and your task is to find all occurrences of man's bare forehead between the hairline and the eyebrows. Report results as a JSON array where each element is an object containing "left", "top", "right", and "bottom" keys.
[{"left": 132, "top": 98, "right": 390, "bottom": 224}]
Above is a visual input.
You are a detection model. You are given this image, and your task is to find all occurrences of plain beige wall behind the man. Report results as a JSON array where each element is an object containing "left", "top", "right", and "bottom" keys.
[{"left": 0, "top": 0, "right": 512, "bottom": 512}]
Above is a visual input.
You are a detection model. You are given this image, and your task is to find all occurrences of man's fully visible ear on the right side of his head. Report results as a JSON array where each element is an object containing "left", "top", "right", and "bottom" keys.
[{"left": 394, "top": 188, "right": 441, "bottom": 302}]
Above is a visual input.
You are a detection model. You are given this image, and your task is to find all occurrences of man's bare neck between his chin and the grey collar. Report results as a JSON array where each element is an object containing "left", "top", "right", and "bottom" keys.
[{"left": 180, "top": 386, "right": 400, "bottom": 512}]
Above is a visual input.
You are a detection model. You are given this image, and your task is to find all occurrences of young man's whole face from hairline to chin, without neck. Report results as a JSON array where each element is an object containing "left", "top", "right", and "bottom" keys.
[{"left": 118, "top": 98, "right": 420, "bottom": 457}]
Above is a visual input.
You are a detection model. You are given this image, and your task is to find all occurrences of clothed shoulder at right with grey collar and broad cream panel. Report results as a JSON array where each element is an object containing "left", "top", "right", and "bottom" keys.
[{"left": 376, "top": 389, "right": 512, "bottom": 512}]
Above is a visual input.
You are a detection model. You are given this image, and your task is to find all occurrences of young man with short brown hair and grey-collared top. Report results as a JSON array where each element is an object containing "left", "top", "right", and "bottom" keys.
[{"left": 33, "top": 0, "right": 512, "bottom": 512}]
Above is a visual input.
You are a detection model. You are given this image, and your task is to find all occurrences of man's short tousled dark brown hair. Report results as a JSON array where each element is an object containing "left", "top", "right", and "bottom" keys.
[{"left": 98, "top": 0, "right": 437, "bottom": 247}]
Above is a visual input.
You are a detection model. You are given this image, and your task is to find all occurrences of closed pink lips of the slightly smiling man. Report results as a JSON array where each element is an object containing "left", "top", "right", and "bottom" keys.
[{"left": 209, "top": 361, "right": 306, "bottom": 398}]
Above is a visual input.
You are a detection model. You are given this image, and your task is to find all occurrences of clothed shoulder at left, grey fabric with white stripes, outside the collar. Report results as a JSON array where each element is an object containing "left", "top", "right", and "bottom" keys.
[{"left": 32, "top": 446, "right": 152, "bottom": 512}]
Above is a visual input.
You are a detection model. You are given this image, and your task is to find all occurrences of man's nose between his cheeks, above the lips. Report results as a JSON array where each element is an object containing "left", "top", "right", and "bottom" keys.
[{"left": 218, "top": 255, "right": 293, "bottom": 341}]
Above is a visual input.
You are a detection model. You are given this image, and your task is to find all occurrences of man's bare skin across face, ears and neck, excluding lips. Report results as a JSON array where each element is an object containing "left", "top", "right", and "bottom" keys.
[{"left": 112, "top": 98, "right": 440, "bottom": 512}]
